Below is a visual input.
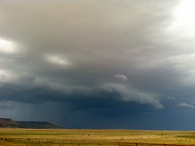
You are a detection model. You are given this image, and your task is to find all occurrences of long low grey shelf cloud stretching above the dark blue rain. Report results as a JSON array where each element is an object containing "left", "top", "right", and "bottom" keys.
[{"left": 0, "top": 82, "right": 164, "bottom": 109}]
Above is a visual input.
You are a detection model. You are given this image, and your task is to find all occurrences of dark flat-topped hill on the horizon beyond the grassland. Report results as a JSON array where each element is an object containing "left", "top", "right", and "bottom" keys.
[{"left": 0, "top": 118, "right": 63, "bottom": 129}]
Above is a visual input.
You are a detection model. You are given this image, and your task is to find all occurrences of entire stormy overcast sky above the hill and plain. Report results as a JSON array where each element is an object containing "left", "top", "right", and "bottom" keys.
[{"left": 0, "top": 0, "right": 195, "bottom": 130}]
